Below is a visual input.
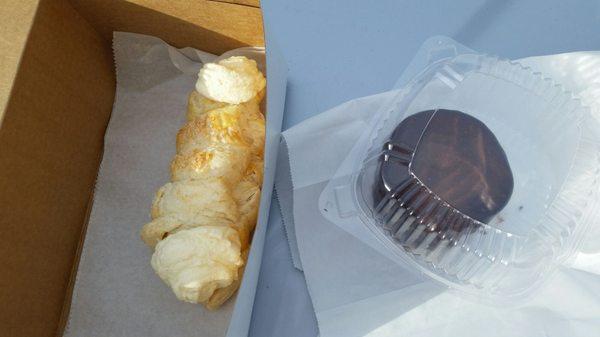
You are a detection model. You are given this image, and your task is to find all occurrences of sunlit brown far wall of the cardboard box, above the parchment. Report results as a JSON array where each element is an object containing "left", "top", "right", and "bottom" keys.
[{"left": 71, "top": 0, "right": 264, "bottom": 54}]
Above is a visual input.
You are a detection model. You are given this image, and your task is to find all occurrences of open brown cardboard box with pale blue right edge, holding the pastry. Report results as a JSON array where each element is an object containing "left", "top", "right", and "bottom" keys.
[{"left": 0, "top": 0, "right": 285, "bottom": 336}]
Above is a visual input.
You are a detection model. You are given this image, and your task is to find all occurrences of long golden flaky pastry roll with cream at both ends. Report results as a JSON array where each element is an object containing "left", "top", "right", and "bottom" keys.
[{"left": 141, "top": 57, "right": 265, "bottom": 310}]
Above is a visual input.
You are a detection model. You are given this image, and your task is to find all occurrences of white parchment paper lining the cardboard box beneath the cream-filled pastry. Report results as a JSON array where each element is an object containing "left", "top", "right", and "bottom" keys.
[{"left": 64, "top": 33, "right": 258, "bottom": 337}]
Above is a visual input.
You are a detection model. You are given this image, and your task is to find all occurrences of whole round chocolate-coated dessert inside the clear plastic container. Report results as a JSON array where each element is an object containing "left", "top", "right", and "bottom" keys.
[{"left": 375, "top": 109, "right": 514, "bottom": 249}]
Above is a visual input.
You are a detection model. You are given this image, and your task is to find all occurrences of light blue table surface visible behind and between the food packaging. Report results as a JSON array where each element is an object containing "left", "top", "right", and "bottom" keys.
[{"left": 250, "top": 0, "right": 600, "bottom": 337}]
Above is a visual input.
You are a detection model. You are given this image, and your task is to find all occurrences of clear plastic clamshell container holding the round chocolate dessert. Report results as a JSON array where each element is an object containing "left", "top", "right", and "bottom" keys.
[{"left": 319, "top": 49, "right": 600, "bottom": 299}]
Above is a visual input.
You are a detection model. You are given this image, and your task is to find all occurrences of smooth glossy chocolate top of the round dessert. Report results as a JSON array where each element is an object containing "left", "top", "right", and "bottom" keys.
[{"left": 375, "top": 109, "right": 514, "bottom": 223}]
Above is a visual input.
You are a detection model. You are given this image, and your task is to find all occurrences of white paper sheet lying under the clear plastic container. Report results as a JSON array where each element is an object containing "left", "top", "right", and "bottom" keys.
[{"left": 276, "top": 52, "right": 600, "bottom": 337}]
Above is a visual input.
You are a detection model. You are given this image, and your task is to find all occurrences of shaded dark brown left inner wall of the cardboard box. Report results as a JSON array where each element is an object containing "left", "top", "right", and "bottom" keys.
[{"left": 0, "top": 0, "right": 114, "bottom": 336}]
